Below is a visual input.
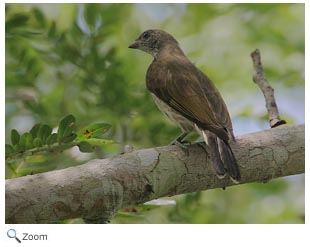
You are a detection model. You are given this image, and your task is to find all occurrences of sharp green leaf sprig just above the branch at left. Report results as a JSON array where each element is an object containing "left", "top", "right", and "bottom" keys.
[{"left": 5, "top": 115, "right": 113, "bottom": 163}]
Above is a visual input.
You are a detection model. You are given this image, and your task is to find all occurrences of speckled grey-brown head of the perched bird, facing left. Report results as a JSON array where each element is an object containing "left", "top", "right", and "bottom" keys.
[{"left": 128, "top": 29, "right": 179, "bottom": 58}]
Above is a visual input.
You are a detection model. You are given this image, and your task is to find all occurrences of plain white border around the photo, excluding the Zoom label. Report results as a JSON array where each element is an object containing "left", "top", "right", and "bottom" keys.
[{"left": 0, "top": 1, "right": 310, "bottom": 247}]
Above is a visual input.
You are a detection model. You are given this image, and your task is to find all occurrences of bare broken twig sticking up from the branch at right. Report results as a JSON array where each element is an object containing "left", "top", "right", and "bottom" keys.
[{"left": 251, "top": 49, "right": 286, "bottom": 128}]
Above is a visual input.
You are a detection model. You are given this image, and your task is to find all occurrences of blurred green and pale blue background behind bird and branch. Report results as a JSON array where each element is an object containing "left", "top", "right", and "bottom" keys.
[{"left": 5, "top": 4, "right": 305, "bottom": 223}]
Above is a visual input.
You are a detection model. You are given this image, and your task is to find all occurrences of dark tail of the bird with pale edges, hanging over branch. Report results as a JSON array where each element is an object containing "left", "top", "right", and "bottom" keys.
[{"left": 202, "top": 130, "right": 241, "bottom": 183}]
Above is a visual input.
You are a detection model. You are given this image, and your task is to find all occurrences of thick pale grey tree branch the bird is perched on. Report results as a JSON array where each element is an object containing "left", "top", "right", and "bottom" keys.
[{"left": 5, "top": 125, "right": 305, "bottom": 223}]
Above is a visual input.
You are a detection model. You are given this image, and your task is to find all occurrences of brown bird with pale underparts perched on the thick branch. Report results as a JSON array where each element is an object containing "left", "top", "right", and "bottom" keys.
[{"left": 128, "top": 29, "right": 241, "bottom": 183}]
